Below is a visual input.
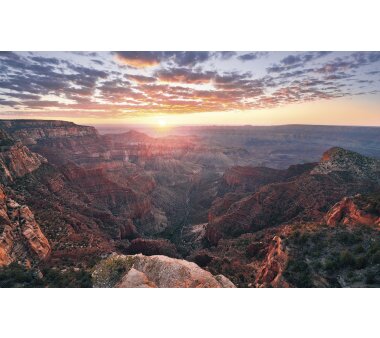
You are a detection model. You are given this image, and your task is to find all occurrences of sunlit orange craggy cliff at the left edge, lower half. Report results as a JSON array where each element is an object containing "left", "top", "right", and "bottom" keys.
[{"left": 0, "top": 188, "right": 51, "bottom": 266}]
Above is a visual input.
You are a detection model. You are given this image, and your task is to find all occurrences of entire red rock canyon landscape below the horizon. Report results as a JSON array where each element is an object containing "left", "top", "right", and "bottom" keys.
[{"left": 0, "top": 119, "right": 380, "bottom": 288}]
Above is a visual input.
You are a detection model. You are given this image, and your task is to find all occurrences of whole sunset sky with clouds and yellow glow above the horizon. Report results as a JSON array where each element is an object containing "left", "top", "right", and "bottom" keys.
[{"left": 0, "top": 51, "right": 380, "bottom": 127}]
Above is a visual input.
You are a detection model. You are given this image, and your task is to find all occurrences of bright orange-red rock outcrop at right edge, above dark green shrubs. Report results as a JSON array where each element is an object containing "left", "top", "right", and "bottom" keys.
[{"left": 325, "top": 196, "right": 380, "bottom": 226}]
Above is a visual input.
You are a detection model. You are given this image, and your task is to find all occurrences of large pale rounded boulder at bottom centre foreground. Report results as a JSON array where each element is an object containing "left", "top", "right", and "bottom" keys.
[{"left": 92, "top": 254, "right": 235, "bottom": 288}]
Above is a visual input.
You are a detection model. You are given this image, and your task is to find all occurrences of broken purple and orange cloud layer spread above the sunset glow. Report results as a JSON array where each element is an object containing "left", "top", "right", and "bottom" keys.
[{"left": 0, "top": 52, "right": 380, "bottom": 116}]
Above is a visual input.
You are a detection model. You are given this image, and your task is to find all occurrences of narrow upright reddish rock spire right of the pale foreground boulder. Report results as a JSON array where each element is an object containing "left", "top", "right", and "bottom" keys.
[{"left": 255, "top": 236, "right": 289, "bottom": 288}]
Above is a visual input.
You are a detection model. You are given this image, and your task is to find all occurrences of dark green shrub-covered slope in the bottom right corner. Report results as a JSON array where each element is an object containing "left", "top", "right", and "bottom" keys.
[{"left": 284, "top": 226, "right": 380, "bottom": 287}]
